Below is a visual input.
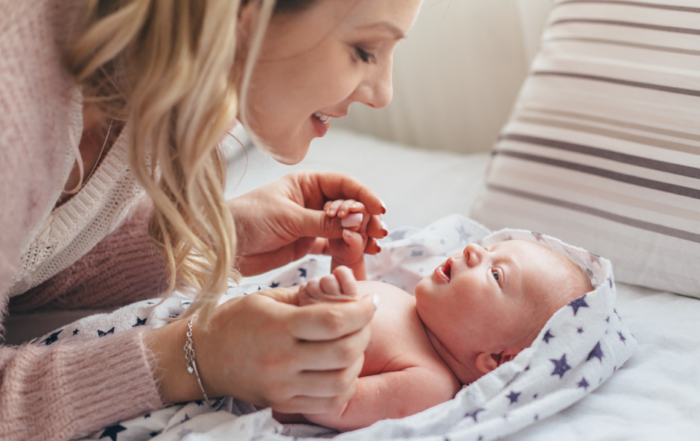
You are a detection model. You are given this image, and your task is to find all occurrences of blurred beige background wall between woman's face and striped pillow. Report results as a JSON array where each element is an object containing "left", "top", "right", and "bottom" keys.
[{"left": 333, "top": 0, "right": 552, "bottom": 153}]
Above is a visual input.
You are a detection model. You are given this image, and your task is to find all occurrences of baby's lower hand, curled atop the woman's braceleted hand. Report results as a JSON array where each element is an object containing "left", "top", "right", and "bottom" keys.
[{"left": 299, "top": 266, "right": 357, "bottom": 306}]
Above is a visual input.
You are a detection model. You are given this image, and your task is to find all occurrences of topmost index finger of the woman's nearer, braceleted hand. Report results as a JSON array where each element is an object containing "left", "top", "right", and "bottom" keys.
[{"left": 287, "top": 295, "right": 376, "bottom": 342}]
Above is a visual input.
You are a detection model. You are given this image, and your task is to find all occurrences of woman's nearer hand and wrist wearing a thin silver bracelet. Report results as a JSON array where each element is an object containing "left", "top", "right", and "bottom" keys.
[{"left": 145, "top": 288, "right": 376, "bottom": 414}]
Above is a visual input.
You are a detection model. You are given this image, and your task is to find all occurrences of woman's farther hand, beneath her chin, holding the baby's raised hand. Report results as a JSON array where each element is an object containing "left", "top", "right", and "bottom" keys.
[{"left": 228, "top": 171, "right": 388, "bottom": 276}]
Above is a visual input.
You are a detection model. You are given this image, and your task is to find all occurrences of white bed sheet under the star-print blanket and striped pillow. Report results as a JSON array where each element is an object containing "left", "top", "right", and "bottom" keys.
[{"left": 227, "top": 130, "right": 700, "bottom": 440}]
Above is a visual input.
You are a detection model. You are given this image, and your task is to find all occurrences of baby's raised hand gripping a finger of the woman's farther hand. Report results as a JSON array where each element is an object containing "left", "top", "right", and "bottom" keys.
[{"left": 324, "top": 199, "right": 370, "bottom": 270}]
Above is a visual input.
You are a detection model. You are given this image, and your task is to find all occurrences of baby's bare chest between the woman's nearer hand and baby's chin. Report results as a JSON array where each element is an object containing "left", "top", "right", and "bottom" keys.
[{"left": 360, "top": 282, "right": 442, "bottom": 377}]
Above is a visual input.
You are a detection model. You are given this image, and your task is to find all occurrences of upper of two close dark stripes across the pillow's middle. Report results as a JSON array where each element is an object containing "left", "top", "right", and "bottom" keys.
[{"left": 500, "top": 133, "right": 700, "bottom": 175}]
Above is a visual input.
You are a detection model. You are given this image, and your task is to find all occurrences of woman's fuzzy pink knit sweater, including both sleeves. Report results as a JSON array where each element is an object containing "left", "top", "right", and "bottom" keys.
[{"left": 0, "top": 0, "right": 163, "bottom": 440}]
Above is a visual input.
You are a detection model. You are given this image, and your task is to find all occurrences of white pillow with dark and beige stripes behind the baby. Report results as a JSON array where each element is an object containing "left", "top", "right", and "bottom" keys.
[{"left": 472, "top": 0, "right": 700, "bottom": 297}]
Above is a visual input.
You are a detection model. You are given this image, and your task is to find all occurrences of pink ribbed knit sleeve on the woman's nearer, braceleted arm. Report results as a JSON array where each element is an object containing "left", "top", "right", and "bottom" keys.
[{"left": 0, "top": 330, "right": 163, "bottom": 441}]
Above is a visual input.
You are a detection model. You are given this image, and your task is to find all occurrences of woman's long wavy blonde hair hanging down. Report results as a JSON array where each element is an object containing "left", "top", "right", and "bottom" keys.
[{"left": 66, "top": 0, "right": 275, "bottom": 322}]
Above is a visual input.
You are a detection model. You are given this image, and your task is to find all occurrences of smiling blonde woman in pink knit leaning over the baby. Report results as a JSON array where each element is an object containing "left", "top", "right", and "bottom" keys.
[{"left": 0, "top": 0, "right": 420, "bottom": 439}]
